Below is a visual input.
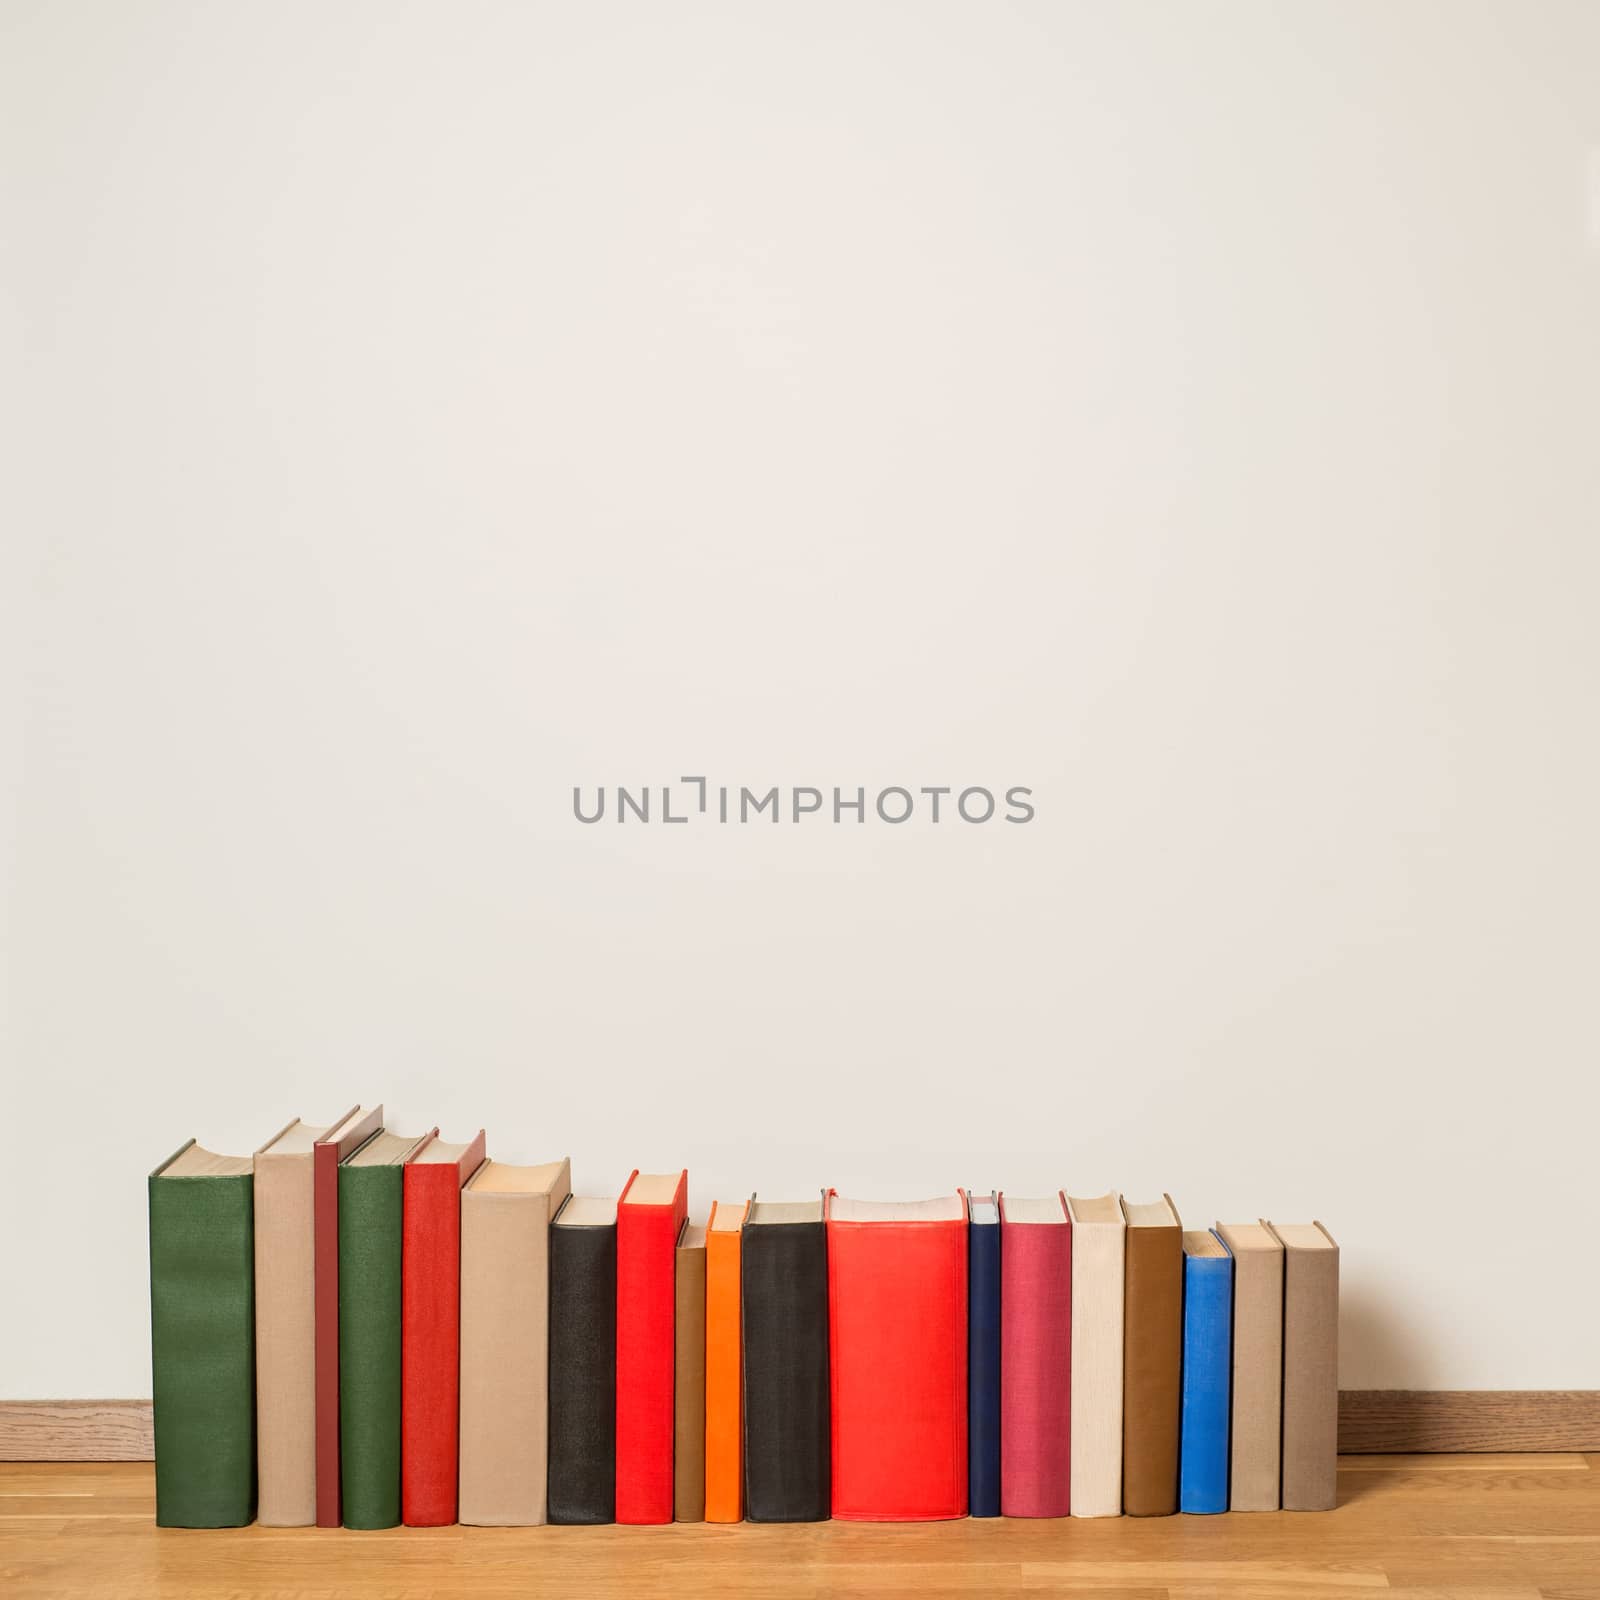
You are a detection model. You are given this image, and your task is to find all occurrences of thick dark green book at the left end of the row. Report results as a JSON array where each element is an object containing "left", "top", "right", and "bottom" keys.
[{"left": 149, "top": 1139, "right": 256, "bottom": 1528}]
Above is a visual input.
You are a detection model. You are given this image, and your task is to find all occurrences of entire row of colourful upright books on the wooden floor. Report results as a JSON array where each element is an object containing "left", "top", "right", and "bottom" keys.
[{"left": 149, "top": 1107, "right": 1339, "bottom": 1528}]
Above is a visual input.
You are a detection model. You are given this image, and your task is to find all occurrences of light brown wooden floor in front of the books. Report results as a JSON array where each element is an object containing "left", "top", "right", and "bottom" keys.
[{"left": 0, "top": 1454, "right": 1600, "bottom": 1600}]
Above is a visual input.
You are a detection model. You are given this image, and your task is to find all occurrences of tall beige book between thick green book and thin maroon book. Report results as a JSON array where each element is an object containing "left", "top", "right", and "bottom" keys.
[{"left": 253, "top": 1112, "right": 352, "bottom": 1528}]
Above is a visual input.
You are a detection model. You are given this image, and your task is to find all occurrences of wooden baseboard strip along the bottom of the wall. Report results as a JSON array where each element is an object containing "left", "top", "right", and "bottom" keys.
[{"left": 0, "top": 1389, "right": 1600, "bottom": 1461}]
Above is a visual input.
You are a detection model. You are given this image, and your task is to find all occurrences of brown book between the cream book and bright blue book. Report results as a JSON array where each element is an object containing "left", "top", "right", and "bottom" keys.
[{"left": 1122, "top": 1195, "right": 1184, "bottom": 1517}]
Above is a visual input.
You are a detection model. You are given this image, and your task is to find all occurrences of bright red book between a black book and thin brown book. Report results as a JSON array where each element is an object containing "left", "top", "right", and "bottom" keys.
[{"left": 616, "top": 1171, "right": 690, "bottom": 1523}]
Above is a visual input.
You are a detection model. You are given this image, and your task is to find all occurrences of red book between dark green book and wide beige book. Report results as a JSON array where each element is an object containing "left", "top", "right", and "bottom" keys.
[{"left": 400, "top": 1128, "right": 485, "bottom": 1528}]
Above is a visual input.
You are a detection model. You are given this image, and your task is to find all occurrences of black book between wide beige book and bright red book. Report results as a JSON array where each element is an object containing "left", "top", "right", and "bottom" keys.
[{"left": 547, "top": 1195, "right": 616, "bottom": 1523}]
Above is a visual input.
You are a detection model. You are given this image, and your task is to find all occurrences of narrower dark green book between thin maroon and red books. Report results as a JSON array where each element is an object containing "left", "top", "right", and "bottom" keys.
[{"left": 339, "top": 1130, "right": 437, "bottom": 1528}]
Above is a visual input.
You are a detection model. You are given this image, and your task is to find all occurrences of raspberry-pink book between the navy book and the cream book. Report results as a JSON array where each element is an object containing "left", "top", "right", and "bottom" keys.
[{"left": 1000, "top": 1194, "right": 1072, "bottom": 1517}]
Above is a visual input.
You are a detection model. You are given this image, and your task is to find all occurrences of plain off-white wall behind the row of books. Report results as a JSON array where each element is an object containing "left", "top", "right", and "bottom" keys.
[{"left": 0, "top": 0, "right": 1600, "bottom": 1397}]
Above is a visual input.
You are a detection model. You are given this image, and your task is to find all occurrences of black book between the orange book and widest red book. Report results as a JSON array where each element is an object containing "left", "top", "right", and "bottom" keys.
[{"left": 739, "top": 1195, "right": 829, "bottom": 1522}]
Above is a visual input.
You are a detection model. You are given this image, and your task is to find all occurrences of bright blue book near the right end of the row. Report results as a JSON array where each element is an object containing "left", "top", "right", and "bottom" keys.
[{"left": 1178, "top": 1234, "right": 1234, "bottom": 1512}]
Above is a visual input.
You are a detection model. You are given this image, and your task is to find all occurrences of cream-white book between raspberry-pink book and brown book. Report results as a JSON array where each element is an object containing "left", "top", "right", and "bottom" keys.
[{"left": 1067, "top": 1190, "right": 1128, "bottom": 1517}]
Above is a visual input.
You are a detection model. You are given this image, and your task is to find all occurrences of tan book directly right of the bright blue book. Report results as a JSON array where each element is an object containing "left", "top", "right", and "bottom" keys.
[{"left": 1216, "top": 1222, "right": 1283, "bottom": 1510}]
